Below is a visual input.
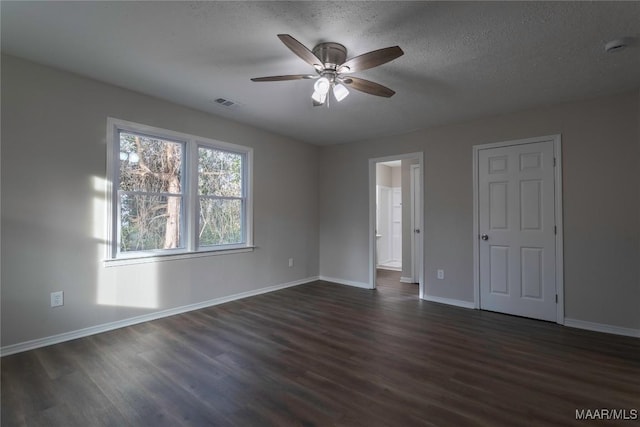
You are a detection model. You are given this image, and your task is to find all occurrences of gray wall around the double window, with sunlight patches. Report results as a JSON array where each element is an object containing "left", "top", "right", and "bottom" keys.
[{"left": 1, "top": 56, "right": 320, "bottom": 346}]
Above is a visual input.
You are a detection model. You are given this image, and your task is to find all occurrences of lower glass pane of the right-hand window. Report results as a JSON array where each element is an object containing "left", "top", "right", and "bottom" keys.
[{"left": 199, "top": 198, "right": 243, "bottom": 246}]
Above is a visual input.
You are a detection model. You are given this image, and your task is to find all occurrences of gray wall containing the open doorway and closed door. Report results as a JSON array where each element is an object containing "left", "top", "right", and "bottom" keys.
[{"left": 320, "top": 91, "right": 640, "bottom": 329}]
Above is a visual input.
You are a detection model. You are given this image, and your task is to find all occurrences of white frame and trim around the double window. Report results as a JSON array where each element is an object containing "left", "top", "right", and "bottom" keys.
[{"left": 105, "top": 117, "right": 254, "bottom": 265}]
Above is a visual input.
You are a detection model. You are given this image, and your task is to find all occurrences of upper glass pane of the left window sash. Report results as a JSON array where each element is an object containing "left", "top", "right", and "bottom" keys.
[{"left": 120, "top": 132, "right": 183, "bottom": 193}]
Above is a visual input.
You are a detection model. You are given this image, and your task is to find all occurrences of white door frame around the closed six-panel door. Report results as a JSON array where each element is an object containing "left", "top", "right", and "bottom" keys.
[{"left": 473, "top": 134, "right": 564, "bottom": 325}]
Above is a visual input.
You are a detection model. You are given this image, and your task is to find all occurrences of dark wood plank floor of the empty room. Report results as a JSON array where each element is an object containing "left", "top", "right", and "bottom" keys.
[{"left": 2, "top": 273, "right": 640, "bottom": 427}]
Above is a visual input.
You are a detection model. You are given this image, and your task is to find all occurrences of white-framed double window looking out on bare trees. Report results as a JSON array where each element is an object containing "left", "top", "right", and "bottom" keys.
[{"left": 107, "top": 118, "right": 252, "bottom": 259}]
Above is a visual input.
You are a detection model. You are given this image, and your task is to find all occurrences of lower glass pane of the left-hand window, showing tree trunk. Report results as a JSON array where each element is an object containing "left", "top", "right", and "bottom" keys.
[{"left": 120, "top": 193, "right": 182, "bottom": 252}]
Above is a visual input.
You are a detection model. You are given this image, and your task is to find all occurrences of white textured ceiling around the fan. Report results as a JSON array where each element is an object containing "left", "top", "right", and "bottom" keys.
[{"left": 0, "top": 1, "right": 640, "bottom": 144}]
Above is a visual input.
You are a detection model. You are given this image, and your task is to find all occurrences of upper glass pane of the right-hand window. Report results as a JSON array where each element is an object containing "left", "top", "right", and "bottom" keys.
[{"left": 198, "top": 147, "right": 243, "bottom": 197}]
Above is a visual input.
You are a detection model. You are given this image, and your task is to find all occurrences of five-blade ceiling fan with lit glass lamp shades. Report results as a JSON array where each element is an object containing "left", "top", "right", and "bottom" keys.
[{"left": 251, "top": 34, "right": 404, "bottom": 106}]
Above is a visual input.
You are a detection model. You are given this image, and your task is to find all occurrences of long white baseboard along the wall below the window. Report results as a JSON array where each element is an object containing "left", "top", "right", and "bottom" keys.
[{"left": 0, "top": 276, "right": 319, "bottom": 357}]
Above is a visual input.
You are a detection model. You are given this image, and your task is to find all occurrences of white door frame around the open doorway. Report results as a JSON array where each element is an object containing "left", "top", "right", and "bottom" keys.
[{"left": 369, "top": 152, "right": 426, "bottom": 299}]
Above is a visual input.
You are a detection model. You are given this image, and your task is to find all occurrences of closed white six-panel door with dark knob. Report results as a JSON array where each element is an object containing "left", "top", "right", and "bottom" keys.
[{"left": 478, "top": 141, "right": 557, "bottom": 321}]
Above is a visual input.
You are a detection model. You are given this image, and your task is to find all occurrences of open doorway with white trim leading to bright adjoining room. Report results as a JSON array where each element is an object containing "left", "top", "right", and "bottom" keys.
[{"left": 369, "top": 153, "right": 424, "bottom": 298}]
